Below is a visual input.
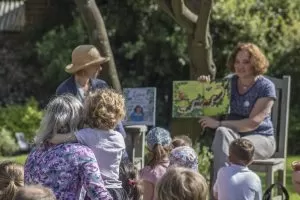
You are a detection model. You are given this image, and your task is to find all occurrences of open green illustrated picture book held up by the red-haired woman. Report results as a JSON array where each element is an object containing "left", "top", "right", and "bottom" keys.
[{"left": 172, "top": 80, "right": 230, "bottom": 118}]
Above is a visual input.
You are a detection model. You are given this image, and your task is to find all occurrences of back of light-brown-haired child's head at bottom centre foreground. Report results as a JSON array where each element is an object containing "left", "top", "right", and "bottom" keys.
[{"left": 156, "top": 167, "right": 208, "bottom": 200}]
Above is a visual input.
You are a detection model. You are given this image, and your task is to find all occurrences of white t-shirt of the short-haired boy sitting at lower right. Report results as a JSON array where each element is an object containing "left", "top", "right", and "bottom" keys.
[{"left": 213, "top": 164, "right": 262, "bottom": 200}]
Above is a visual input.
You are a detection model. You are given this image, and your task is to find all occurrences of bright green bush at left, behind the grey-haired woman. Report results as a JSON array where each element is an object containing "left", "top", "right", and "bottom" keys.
[{"left": 0, "top": 98, "right": 42, "bottom": 141}]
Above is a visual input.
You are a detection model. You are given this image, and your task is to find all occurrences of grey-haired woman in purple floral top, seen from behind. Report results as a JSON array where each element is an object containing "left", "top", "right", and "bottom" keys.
[{"left": 25, "top": 95, "right": 112, "bottom": 200}]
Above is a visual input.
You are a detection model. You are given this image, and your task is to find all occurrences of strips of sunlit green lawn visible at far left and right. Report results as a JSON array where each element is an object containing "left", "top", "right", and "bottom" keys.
[{"left": 0, "top": 154, "right": 300, "bottom": 200}]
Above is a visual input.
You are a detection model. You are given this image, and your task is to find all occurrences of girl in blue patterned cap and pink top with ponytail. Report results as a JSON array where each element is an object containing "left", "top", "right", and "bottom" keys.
[{"left": 140, "top": 127, "right": 171, "bottom": 200}]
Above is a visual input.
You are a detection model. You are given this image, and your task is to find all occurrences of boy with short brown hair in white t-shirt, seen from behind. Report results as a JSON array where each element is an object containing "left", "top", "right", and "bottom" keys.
[{"left": 213, "top": 138, "right": 262, "bottom": 200}]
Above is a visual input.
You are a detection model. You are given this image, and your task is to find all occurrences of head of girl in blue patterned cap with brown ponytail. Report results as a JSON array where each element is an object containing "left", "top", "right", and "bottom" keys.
[{"left": 146, "top": 127, "right": 172, "bottom": 167}]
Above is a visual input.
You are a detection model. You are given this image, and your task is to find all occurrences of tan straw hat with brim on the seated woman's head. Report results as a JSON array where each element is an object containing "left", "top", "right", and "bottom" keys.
[{"left": 65, "top": 45, "right": 109, "bottom": 74}]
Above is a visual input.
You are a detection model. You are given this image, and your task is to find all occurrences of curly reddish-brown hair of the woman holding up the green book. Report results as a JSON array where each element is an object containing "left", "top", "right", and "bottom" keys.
[{"left": 227, "top": 43, "right": 269, "bottom": 75}]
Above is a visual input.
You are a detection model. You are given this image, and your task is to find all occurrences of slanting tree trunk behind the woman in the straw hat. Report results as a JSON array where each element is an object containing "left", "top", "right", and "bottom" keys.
[{"left": 75, "top": 0, "right": 122, "bottom": 91}]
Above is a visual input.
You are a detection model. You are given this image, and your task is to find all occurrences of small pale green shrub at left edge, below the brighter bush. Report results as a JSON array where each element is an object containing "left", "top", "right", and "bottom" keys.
[{"left": 0, "top": 128, "right": 18, "bottom": 156}]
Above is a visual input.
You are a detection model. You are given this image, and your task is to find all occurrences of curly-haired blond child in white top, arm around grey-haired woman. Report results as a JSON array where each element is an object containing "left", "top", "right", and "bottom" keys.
[{"left": 50, "top": 88, "right": 128, "bottom": 199}]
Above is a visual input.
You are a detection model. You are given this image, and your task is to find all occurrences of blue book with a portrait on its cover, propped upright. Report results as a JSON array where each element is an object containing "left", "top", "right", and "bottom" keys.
[{"left": 123, "top": 87, "right": 156, "bottom": 126}]
